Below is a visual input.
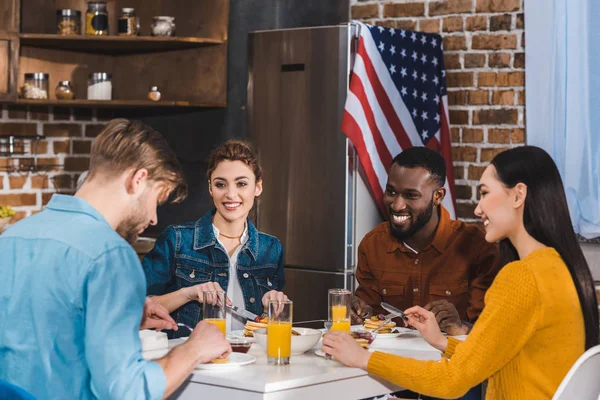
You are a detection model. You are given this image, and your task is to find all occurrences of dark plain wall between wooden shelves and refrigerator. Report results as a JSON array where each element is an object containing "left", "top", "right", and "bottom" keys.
[{"left": 120, "top": 0, "right": 350, "bottom": 236}]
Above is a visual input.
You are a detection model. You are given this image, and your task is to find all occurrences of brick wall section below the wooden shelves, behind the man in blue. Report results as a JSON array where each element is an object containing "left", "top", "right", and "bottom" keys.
[{"left": 0, "top": 105, "right": 111, "bottom": 223}]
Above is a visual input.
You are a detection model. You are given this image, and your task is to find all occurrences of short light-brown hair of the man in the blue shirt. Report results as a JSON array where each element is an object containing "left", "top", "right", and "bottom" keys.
[{"left": 87, "top": 119, "right": 187, "bottom": 202}]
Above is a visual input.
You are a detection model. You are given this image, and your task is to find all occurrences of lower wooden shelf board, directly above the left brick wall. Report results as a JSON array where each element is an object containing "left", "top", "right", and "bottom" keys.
[{"left": 5, "top": 99, "right": 225, "bottom": 108}]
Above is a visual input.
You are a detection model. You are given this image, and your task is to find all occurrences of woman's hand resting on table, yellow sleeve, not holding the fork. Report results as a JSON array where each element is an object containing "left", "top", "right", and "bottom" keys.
[{"left": 321, "top": 331, "right": 371, "bottom": 370}]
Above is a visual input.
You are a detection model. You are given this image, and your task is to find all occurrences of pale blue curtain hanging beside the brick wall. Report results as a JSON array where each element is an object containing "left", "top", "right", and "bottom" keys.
[{"left": 525, "top": 0, "right": 600, "bottom": 238}]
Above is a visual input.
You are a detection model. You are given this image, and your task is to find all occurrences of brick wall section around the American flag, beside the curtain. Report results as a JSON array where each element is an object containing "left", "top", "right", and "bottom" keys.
[{"left": 351, "top": 0, "right": 525, "bottom": 220}]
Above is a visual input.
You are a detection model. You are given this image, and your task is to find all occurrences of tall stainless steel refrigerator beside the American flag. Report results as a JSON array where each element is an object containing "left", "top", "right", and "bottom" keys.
[{"left": 248, "top": 24, "right": 381, "bottom": 321}]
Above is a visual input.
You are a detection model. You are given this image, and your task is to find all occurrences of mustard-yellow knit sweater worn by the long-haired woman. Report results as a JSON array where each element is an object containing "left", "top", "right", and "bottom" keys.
[{"left": 368, "top": 248, "right": 585, "bottom": 400}]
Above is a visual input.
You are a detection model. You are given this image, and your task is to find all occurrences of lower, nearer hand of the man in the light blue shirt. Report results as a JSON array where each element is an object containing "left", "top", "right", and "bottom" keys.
[{"left": 186, "top": 321, "right": 231, "bottom": 364}]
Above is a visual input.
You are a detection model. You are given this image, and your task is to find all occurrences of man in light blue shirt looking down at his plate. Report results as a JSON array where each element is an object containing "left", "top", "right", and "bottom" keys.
[{"left": 0, "top": 120, "right": 231, "bottom": 399}]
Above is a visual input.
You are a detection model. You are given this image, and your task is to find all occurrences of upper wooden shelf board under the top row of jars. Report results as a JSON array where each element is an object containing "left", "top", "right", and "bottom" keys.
[{"left": 20, "top": 33, "right": 227, "bottom": 55}]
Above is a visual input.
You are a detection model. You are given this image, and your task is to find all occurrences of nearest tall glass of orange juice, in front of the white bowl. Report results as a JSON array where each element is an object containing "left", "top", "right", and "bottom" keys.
[{"left": 267, "top": 300, "right": 294, "bottom": 365}]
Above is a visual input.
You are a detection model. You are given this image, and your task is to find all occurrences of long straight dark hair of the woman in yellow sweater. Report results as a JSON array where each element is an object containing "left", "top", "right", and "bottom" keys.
[{"left": 492, "top": 146, "right": 599, "bottom": 350}]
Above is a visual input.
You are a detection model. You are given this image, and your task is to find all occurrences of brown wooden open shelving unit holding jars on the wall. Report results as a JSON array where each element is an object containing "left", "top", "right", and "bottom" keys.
[{"left": 0, "top": 0, "right": 229, "bottom": 108}]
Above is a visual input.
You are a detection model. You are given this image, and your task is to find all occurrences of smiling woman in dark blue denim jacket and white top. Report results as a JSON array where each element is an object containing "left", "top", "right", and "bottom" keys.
[{"left": 142, "top": 140, "right": 287, "bottom": 337}]
